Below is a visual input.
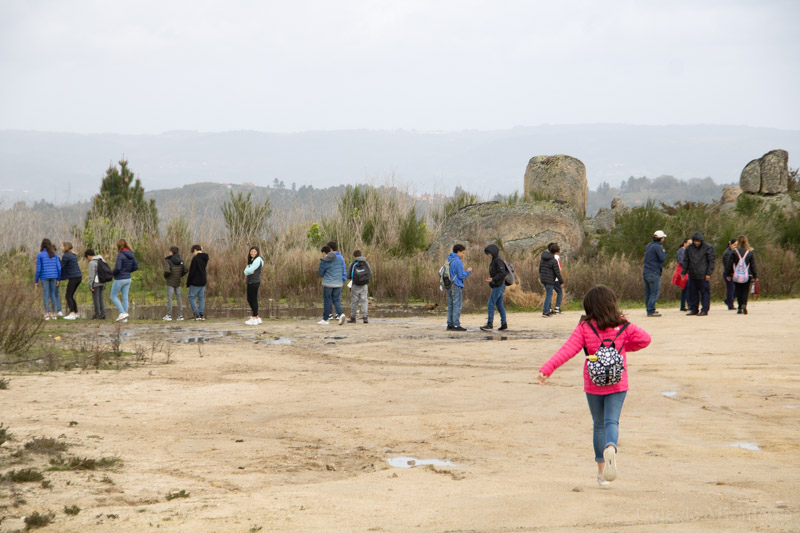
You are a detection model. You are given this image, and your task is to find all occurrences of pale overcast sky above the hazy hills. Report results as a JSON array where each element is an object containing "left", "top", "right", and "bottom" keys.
[{"left": 0, "top": 0, "right": 800, "bottom": 133}]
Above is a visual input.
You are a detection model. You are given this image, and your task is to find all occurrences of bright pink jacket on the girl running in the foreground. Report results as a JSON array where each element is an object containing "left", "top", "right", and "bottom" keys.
[{"left": 539, "top": 320, "right": 650, "bottom": 395}]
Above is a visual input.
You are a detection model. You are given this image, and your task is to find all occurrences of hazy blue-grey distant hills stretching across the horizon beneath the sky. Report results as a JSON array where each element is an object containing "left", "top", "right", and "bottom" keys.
[{"left": 0, "top": 124, "right": 800, "bottom": 207}]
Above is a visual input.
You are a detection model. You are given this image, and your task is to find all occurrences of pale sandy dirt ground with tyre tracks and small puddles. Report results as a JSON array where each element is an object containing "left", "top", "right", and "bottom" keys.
[{"left": 0, "top": 300, "right": 800, "bottom": 533}]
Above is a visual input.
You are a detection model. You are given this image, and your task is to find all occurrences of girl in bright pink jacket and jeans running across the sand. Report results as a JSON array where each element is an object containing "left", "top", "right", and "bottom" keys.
[{"left": 539, "top": 285, "right": 650, "bottom": 486}]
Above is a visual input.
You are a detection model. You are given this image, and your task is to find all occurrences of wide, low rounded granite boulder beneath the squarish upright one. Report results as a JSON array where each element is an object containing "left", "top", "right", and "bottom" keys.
[{"left": 427, "top": 201, "right": 583, "bottom": 257}]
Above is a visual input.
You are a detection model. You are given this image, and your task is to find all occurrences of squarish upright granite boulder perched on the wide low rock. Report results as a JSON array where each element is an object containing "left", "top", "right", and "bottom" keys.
[{"left": 524, "top": 155, "right": 588, "bottom": 217}]
